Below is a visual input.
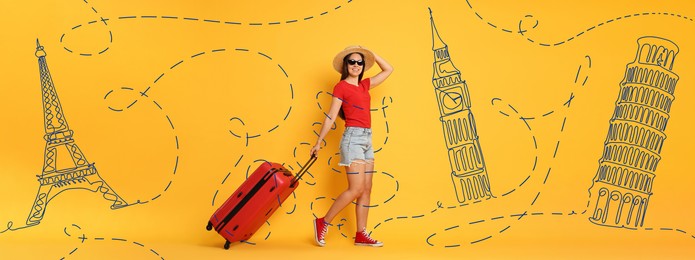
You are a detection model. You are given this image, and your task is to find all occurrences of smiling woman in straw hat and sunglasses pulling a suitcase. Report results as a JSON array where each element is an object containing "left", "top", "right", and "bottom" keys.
[{"left": 311, "top": 46, "right": 393, "bottom": 246}]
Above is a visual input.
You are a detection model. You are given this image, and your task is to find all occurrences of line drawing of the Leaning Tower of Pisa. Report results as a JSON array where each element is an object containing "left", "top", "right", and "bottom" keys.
[{"left": 589, "top": 36, "right": 679, "bottom": 228}]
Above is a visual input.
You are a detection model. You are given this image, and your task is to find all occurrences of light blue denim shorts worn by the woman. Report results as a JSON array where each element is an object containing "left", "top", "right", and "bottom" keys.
[{"left": 338, "top": 126, "right": 374, "bottom": 166}]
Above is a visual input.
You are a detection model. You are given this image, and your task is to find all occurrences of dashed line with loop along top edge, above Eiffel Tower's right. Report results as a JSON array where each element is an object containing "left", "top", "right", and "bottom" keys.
[{"left": 60, "top": 0, "right": 353, "bottom": 57}]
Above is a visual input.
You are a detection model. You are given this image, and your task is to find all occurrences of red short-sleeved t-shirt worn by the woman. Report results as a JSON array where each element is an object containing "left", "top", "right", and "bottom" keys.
[{"left": 333, "top": 78, "right": 372, "bottom": 128}]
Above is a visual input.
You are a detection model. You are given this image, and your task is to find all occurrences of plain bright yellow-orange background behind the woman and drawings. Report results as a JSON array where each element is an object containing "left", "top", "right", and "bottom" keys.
[{"left": 0, "top": 0, "right": 695, "bottom": 259}]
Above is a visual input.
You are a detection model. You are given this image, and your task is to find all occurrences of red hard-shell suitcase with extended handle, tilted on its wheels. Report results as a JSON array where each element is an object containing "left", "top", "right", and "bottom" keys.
[{"left": 207, "top": 156, "right": 316, "bottom": 249}]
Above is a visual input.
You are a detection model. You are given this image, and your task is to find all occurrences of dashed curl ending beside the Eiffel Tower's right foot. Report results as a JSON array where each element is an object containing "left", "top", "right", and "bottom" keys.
[{"left": 104, "top": 87, "right": 180, "bottom": 204}]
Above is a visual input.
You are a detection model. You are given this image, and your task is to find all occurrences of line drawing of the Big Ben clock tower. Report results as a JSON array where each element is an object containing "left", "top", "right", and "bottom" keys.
[{"left": 428, "top": 8, "right": 495, "bottom": 203}]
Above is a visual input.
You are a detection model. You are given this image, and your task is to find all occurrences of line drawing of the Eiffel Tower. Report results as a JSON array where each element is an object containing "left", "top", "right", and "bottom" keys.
[{"left": 27, "top": 39, "right": 128, "bottom": 226}]
